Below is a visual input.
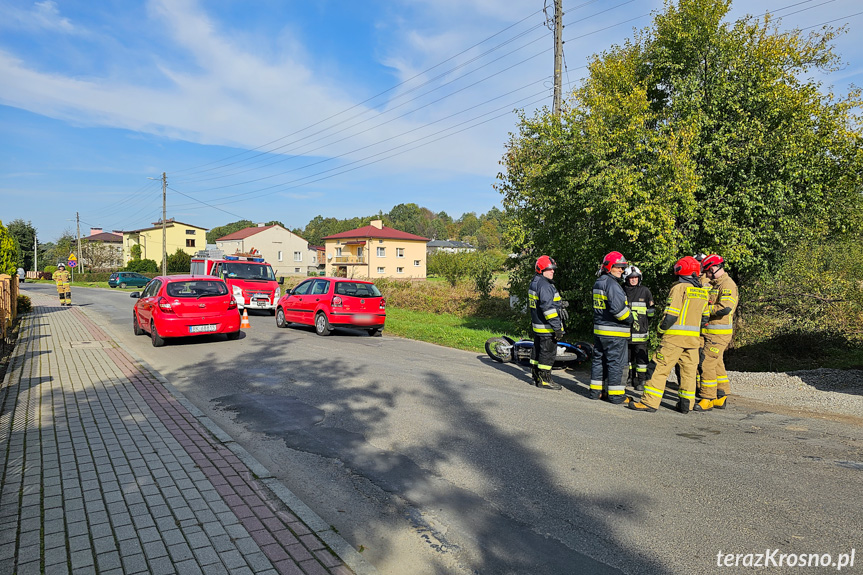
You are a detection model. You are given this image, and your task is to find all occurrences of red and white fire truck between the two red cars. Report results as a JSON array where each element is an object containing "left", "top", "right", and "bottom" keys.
[{"left": 189, "top": 248, "right": 285, "bottom": 314}]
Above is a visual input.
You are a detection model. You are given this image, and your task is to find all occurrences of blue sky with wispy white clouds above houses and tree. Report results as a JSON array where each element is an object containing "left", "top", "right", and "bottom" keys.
[{"left": 0, "top": 0, "right": 863, "bottom": 241}]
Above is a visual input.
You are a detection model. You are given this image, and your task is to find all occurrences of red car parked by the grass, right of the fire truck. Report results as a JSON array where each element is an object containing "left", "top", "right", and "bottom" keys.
[{"left": 276, "top": 278, "right": 387, "bottom": 335}]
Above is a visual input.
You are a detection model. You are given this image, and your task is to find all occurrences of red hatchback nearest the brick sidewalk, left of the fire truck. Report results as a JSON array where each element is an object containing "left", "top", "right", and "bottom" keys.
[{"left": 130, "top": 275, "right": 240, "bottom": 347}]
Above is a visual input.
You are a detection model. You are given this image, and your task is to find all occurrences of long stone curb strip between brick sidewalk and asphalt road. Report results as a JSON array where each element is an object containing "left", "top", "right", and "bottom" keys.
[{"left": 79, "top": 307, "right": 379, "bottom": 575}]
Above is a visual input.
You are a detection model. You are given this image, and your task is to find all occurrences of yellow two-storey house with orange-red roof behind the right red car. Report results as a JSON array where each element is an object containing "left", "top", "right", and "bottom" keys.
[{"left": 323, "top": 220, "right": 429, "bottom": 279}]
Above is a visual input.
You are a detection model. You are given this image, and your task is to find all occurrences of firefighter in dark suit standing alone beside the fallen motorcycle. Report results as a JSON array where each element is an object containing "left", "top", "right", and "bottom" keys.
[{"left": 527, "top": 256, "right": 563, "bottom": 389}]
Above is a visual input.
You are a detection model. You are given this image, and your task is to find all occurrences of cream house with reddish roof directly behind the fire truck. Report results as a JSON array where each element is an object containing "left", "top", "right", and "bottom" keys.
[{"left": 216, "top": 224, "right": 323, "bottom": 276}]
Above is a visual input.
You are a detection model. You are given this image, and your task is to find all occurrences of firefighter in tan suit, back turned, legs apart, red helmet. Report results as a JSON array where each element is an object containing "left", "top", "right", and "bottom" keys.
[{"left": 629, "top": 256, "right": 708, "bottom": 413}]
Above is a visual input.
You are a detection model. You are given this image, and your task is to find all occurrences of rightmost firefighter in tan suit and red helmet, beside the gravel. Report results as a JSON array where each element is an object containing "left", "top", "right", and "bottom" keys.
[{"left": 695, "top": 254, "right": 737, "bottom": 411}]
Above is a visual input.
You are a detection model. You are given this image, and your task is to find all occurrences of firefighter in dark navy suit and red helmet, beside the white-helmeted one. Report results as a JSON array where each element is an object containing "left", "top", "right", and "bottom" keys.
[{"left": 590, "top": 252, "right": 633, "bottom": 403}]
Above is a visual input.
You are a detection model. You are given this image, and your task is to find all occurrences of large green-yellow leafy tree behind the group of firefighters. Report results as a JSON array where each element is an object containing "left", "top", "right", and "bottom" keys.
[{"left": 498, "top": 0, "right": 863, "bottom": 324}]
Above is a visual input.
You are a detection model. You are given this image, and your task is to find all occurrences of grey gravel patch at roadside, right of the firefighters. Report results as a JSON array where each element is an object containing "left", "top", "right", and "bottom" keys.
[{"left": 728, "top": 368, "right": 863, "bottom": 417}]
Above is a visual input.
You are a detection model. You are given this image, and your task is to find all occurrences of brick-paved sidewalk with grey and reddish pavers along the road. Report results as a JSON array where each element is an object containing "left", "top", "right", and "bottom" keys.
[{"left": 0, "top": 295, "right": 376, "bottom": 575}]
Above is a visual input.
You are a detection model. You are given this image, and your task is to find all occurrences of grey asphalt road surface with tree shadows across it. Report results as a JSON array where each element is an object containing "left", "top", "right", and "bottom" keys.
[{"left": 27, "top": 284, "right": 863, "bottom": 575}]
